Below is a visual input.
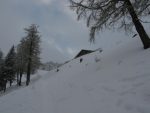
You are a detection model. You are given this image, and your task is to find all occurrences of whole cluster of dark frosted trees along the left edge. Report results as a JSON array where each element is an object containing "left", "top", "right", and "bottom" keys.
[{"left": 0, "top": 24, "right": 41, "bottom": 92}]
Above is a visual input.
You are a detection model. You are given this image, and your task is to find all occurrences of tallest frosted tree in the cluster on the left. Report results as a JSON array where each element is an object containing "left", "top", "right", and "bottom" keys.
[{"left": 25, "top": 24, "right": 41, "bottom": 85}]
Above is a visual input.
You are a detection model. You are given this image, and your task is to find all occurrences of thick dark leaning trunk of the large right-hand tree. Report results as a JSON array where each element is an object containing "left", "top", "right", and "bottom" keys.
[{"left": 125, "top": 0, "right": 150, "bottom": 49}]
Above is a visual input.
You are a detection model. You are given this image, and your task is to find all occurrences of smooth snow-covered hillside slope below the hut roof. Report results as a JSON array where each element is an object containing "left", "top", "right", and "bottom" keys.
[{"left": 0, "top": 39, "right": 150, "bottom": 113}]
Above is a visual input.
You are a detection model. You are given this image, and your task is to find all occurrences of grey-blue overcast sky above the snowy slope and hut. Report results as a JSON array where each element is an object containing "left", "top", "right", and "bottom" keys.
[{"left": 0, "top": 0, "right": 149, "bottom": 62}]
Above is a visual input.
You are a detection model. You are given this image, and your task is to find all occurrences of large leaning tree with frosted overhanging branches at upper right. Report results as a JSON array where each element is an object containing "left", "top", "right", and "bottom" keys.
[{"left": 70, "top": 0, "right": 150, "bottom": 49}]
